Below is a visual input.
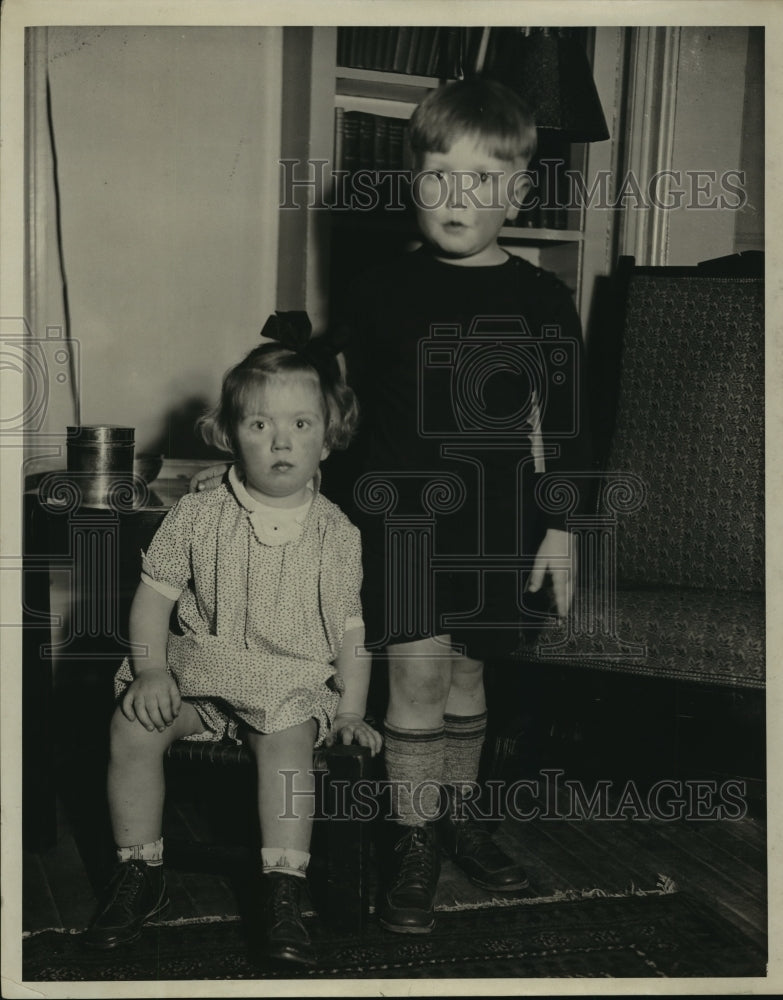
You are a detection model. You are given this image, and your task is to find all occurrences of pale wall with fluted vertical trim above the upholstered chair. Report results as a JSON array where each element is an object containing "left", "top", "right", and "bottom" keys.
[{"left": 618, "top": 26, "right": 764, "bottom": 266}]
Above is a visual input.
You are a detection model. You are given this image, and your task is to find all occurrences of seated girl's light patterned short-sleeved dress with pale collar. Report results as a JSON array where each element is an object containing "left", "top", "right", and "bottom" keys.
[{"left": 115, "top": 468, "right": 363, "bottom": 746}]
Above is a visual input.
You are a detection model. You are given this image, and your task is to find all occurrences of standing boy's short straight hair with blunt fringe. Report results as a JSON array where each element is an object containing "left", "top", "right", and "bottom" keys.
[{"left": 409, "top": 79, "right": 537, "bottom": 166}]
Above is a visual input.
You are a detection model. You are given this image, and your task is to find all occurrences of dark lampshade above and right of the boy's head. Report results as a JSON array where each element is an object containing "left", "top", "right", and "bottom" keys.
[{"left": 484, "top": 28, "right": 609, "bottom": 142}]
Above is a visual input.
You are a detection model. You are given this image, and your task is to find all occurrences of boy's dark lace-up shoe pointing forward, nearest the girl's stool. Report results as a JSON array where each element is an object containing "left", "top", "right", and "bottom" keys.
[{"left": 378, "top": 825, "right": 440, "bottom": 934}]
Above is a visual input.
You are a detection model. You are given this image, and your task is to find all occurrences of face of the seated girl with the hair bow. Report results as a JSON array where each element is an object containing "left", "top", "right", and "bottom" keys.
[{"left": 234, "top": 372, "right": 329, "bottom": 507}]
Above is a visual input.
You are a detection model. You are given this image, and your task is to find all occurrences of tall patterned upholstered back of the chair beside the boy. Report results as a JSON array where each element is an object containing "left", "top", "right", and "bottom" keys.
[{"left": 607, "top": 267, "right": 764, "bottom": 591}]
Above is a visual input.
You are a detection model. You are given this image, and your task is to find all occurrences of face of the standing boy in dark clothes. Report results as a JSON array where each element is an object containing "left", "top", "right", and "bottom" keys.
[{"left": 414, "top": 135, "right": 530, "bottom": 267}]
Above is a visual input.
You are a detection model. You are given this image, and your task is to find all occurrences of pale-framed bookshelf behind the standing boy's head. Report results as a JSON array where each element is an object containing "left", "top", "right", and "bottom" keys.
[{"left": 300, "top": 27, "right": 623, "bottom": 332}]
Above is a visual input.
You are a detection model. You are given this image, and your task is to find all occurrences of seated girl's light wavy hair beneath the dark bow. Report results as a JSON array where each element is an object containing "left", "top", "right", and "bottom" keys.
[{"left": 196, "top": 338, "right": 359, "bottom": 452}]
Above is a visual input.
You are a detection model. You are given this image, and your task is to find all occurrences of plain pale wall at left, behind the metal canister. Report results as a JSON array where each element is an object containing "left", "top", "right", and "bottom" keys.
[{"left": 29, "top": 27, "right": 282, "bottom": 457}]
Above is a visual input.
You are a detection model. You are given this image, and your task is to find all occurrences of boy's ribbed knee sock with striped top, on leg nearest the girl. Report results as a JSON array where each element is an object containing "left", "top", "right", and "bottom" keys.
[{"left": 384, "top": 722, "right": 445, "bottom": 826}]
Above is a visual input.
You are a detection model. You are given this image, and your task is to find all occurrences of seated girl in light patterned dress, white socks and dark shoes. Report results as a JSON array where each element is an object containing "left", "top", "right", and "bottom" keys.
[{"left": 85, "top": 328, "right": 381, "bottom": 965}]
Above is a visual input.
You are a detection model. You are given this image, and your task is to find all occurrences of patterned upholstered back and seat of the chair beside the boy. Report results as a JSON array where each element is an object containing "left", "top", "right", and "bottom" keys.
[{"left": 519, "top": 268, "right": 765, "bottom": 687}]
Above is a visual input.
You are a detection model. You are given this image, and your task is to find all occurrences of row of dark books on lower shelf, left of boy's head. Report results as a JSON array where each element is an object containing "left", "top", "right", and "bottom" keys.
[{"left": 334, "top": 108, "right": 410, "bottom": 173}]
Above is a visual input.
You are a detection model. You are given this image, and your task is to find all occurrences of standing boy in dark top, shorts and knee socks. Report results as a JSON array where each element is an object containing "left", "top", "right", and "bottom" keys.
[{"left": 342, "top": 81, "right": 585, "bottom": 933}]
